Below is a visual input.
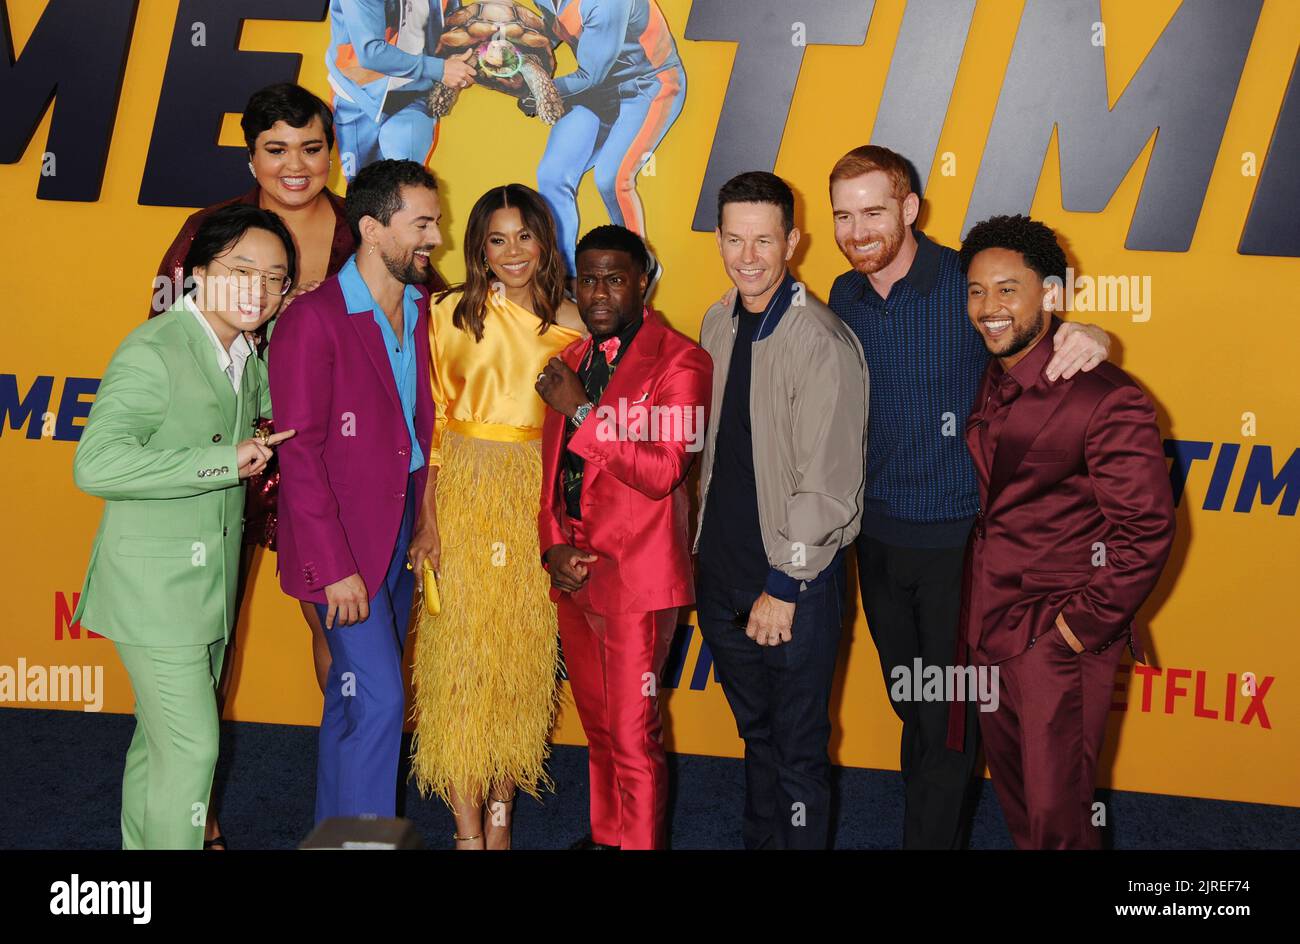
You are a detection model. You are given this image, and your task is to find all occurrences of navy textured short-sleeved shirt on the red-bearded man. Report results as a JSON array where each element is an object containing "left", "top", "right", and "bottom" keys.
[{"left": 829, "top": 231, "right": 988, "bottom": 547}]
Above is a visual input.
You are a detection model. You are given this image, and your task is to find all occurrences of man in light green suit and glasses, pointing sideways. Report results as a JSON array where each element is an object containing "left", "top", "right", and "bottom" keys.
[{"left": 73, "top": 205, "right": 296, "bottom": 849}]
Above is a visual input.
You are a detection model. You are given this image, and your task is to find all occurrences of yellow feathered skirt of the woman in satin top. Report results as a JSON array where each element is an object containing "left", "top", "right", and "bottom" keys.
[{"left": 411, "top": 429, "right": 559, "bottom": 806}]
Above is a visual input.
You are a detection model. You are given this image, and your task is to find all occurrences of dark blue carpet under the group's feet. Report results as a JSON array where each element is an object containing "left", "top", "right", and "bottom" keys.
[{"left": 0, "top": 709, "right": 1300, "bottom": 849}]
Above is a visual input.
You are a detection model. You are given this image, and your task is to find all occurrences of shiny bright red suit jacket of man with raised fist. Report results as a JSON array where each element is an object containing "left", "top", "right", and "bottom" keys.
[{"left": 537, "top": 309, "right": 714, "bottom": 614}]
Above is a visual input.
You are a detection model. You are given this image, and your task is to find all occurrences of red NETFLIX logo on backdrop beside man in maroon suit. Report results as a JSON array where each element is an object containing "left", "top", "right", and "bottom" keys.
[{"left": 1110, "top": 663, "right": 1274, "bottom": 729}]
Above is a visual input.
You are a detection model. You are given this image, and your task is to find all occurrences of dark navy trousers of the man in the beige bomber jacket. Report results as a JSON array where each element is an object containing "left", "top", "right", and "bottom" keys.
[{"left": 696, "top": 564, "right": 844, "bottom": 849}]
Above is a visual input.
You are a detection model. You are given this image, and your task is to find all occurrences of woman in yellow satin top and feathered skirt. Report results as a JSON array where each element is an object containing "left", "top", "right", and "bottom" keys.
[{"left": 412, "top": 183, "right": 586, "bottom": 849}]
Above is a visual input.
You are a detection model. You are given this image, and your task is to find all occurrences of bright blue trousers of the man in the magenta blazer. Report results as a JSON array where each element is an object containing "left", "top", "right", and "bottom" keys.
[{"left": 316, "top": 477, "right": 416, "bottom": 823}]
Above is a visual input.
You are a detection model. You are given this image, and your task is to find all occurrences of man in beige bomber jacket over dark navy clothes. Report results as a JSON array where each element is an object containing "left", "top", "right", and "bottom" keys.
[{"left": 696, "top": 172, "right": 868, "bottom": 849}]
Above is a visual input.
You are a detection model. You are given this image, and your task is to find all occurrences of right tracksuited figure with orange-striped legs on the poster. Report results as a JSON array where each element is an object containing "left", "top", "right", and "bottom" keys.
[{"left": 534, "top": 0, "right": 686, "bottom": 274}]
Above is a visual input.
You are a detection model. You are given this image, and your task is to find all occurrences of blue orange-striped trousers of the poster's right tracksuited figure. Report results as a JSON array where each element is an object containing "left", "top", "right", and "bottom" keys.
[{"left": 537, "top": 68, "right": 686, "bottom": 276}]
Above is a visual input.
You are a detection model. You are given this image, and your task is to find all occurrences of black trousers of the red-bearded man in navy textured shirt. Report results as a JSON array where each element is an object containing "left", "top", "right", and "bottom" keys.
[{"left": 857, "top": 534, "right": 979, "bottom": 849}]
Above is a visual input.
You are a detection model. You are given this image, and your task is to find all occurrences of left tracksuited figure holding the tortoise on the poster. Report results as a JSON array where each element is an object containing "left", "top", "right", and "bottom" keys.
[{"left": 325, "top": 0, "right": 460, "bottom": 181}]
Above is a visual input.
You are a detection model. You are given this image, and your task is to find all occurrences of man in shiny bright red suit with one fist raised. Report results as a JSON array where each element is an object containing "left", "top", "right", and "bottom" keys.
[{"left": 537, "top": 226, "right": 712, "bottom": 849}]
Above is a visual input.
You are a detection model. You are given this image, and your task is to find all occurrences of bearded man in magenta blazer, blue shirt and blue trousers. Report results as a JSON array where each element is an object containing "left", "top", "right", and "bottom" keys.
[{"left": 270, "top": 160, "right": 442, "bottom": 823}]
